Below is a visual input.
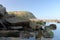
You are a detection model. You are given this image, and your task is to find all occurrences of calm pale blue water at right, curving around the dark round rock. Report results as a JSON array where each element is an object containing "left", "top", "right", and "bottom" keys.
[{"left": 46, "top": 22, "right": 60, "bottom": 40}]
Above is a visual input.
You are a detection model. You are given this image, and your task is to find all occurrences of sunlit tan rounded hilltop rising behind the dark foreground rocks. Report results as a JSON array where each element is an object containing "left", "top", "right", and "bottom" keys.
[{"left": 8, "top": 11, "right": 36, "bottom": 19}]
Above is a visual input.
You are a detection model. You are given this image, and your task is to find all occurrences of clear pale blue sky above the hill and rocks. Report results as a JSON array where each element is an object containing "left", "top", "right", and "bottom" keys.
[{"left": 0, "top": 0, "right": 60, "bottom": 19}]
